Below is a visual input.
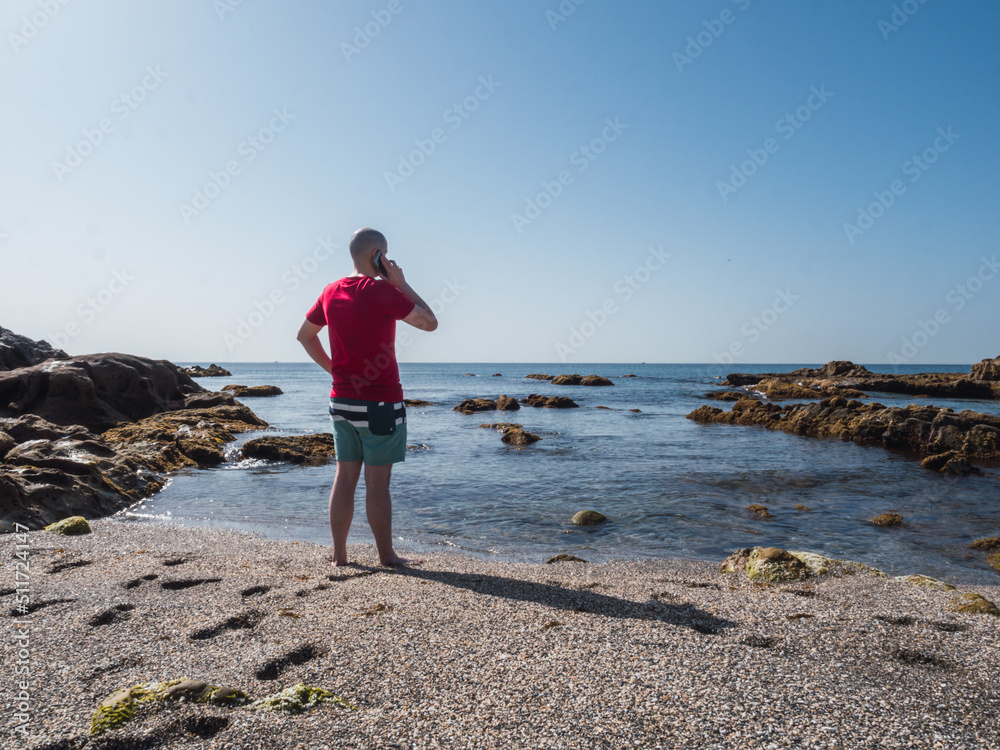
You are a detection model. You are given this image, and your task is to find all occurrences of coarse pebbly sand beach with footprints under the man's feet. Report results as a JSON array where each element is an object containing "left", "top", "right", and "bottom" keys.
[{"left": 2, "top": 519, "right": 1000, "bottom": 749}]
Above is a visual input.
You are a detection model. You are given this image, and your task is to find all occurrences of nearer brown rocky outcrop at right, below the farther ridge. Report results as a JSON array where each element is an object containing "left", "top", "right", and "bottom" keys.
[{"left": 687, "top": 397, "right": 1000, "bottom": 470}]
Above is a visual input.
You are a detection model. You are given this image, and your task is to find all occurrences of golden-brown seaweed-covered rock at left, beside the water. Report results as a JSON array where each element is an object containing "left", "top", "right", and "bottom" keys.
[{"left": 102, "top": 402, "right": 267, "bottom": 472}]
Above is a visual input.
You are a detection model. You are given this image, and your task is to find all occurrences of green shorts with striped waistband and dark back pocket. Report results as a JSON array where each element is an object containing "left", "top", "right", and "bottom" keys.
[{"left": 330, "top": 397, "right": 406, "bottom": 466}]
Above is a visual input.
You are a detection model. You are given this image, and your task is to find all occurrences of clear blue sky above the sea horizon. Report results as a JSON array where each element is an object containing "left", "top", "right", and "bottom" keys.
[{"left": 0, "top": 0, "right": 1000, "bottom": 363}]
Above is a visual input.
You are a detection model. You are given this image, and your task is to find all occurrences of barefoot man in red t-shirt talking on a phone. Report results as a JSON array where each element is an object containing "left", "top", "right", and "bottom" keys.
[{"left": 298, "top": 227, "right": 437, "bottom": 567}]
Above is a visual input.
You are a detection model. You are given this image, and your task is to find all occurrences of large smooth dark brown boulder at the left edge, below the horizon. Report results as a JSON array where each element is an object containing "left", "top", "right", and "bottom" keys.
[{"left": 0, "top": 354, "right": 207, "bottom": 432}]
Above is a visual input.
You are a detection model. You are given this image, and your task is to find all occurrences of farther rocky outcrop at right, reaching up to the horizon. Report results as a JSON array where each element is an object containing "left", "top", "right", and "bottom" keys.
[{"left": 723, "top": 360, "right": 1000, "bottom": 399}]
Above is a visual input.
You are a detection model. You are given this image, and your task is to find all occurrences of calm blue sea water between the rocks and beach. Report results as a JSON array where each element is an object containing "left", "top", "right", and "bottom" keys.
[{"left": 123, "top": 362, "right": 1000, "bottom": 584}]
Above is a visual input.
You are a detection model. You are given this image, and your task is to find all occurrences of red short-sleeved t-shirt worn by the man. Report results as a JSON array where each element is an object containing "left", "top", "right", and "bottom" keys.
[{"left": 306, "top": 276, "right": 416, "bottom": 401}]
